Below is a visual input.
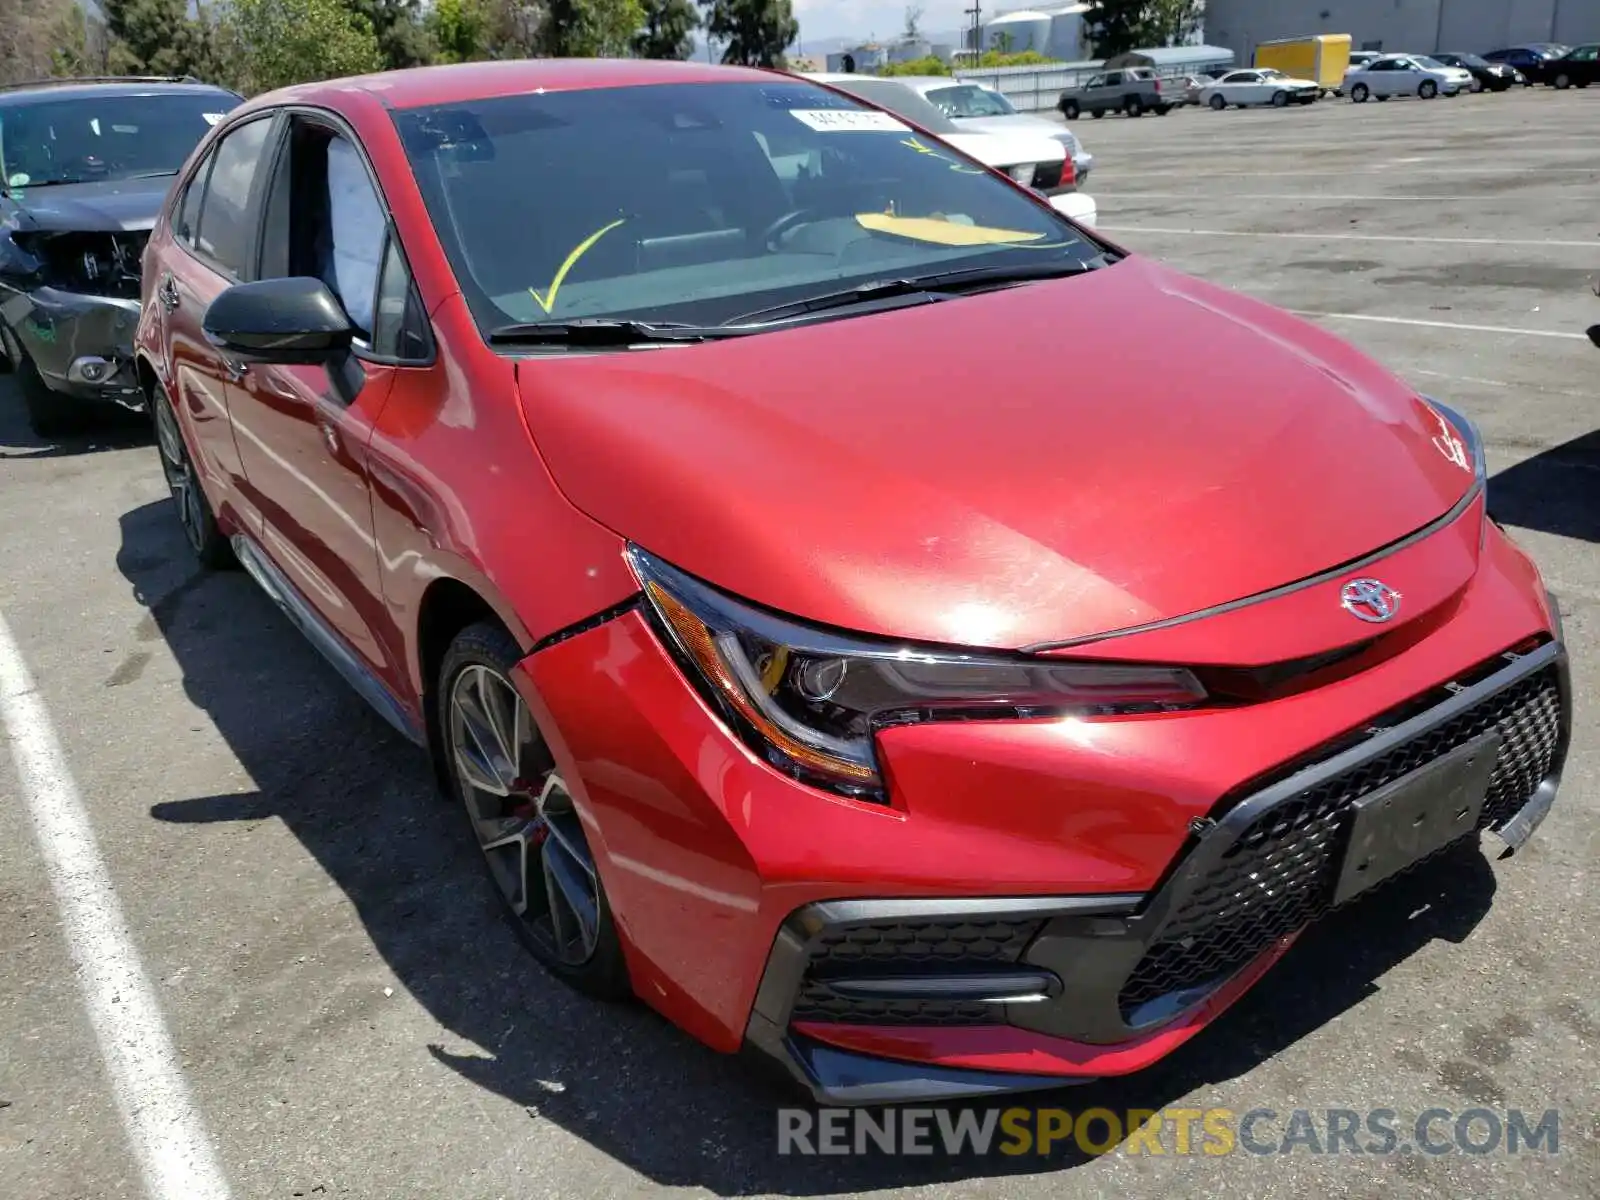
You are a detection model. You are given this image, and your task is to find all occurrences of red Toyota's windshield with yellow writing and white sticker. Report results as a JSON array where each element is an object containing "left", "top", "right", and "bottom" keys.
[{"left": 394, "top": 78, "right": 1104, "bottom": 333}]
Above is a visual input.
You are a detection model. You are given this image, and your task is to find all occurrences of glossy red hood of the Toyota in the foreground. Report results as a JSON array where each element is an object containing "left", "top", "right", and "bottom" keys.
[{"left": 517, "top": 258, "right": 1474, "bottom": 648}]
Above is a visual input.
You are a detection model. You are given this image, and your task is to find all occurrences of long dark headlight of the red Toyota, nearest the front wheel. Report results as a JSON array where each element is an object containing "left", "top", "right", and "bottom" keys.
[{"left": 629, "top": 547, "right": 1206, "bottom": 800}]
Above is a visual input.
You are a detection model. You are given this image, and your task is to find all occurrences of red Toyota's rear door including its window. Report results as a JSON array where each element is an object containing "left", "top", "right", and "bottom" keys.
[{"left": 152, "top": 114, "right": 277, "bottom": 528}]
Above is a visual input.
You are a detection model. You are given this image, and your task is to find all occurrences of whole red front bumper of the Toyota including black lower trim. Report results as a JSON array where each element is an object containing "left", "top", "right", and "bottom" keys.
[{"left": 517, "top": 517, "right": 1571, "bottom": 1102}]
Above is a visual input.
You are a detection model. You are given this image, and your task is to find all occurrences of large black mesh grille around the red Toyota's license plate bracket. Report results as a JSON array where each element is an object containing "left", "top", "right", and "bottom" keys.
[{"left": 1118, "top": 667, "right": 1562, "bottom": 1018}]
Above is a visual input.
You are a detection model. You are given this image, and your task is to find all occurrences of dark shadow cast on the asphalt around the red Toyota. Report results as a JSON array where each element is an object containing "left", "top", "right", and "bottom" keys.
[{"left": 118, "top": 501, "right": 1494, "bottom": 1195}]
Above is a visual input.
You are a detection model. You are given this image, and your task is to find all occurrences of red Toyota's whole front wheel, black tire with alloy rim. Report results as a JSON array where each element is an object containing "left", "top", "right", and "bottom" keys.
[{"left": 438, "top": 622, "right": 632, "bottom": 1000}]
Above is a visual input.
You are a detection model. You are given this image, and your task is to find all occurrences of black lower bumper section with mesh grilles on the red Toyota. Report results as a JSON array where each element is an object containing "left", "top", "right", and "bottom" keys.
[{"left": 746, "top": 640, "right": 1571, "bottom": 1104}]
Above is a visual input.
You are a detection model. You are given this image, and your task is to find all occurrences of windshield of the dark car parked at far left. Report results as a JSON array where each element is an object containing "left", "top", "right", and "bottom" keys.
[{"left": 0, "top": 91, "right": 240, "bottom": 187}]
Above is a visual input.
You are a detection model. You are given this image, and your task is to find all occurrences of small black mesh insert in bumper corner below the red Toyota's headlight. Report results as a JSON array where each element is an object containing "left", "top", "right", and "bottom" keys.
[{"left": 792, "top": 920, "right": 1043, "bottom": 1026}]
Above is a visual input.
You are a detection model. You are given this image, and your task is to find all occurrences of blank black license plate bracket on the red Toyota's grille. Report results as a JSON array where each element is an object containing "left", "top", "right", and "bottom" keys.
[{"left": 1333, "top": 730, "right": 1502, "bottom": 904}]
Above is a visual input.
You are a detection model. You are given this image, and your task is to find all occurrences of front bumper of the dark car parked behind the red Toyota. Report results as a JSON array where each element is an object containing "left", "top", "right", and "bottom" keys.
[{"left": 0, "top": 286, "right": 144, "bottom": 410}]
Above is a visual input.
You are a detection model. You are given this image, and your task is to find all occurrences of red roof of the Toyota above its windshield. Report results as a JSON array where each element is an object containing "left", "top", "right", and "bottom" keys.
[{"left": 253, "top": 58, "right": 777, "bottom": 109}]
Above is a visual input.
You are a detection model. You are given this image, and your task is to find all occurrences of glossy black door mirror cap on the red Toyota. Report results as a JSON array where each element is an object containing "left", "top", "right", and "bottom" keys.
[{"left": 202, "top": 277, "right": 355, "bottom": 363}]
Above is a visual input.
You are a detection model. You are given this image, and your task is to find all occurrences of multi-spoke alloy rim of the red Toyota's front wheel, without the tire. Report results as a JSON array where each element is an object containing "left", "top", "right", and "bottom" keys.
[{"left": 446, "top": 664, "right": 600, "bottom": 966}]
